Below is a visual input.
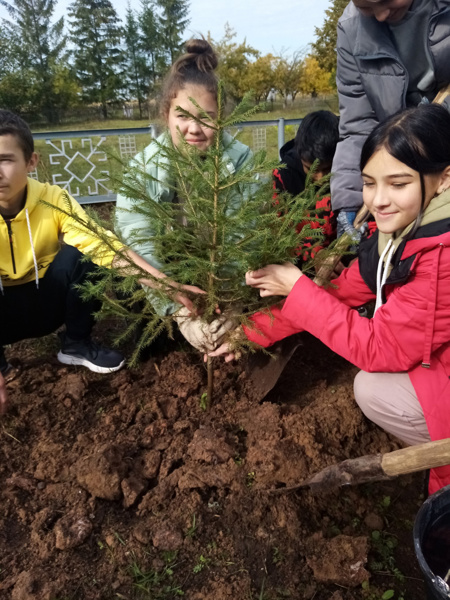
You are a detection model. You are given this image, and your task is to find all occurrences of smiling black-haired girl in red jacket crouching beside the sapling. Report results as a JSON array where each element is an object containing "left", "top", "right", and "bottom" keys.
[{"left": 215, "top": 105, "right": 450, "bottom": 492}]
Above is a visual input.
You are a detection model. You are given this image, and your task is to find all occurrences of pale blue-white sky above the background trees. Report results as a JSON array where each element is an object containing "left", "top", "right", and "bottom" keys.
[{"left": 0, "top": 0, "right": 331, "bottom": 54}]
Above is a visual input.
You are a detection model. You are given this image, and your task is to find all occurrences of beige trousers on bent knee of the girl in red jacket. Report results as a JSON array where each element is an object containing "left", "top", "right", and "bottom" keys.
[{"left": 354, "top": 371, "right": 430, "bottom": 445}]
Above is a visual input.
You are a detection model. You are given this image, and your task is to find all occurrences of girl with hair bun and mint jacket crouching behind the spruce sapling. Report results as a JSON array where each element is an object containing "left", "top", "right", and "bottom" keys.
[{"left": 116, "top": 39, "right": 251, "bottom": 351}]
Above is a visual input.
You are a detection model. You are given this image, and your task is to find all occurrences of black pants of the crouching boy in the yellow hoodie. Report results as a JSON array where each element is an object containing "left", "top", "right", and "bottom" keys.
[{"left": 0, "top": 246, "right": 100, "bottom": 347}]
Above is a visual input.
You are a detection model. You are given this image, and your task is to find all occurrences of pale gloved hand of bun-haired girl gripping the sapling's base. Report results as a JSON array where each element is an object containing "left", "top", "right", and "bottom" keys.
[{"left": 174, "top": 306, "right": 237, "bottom": 352}]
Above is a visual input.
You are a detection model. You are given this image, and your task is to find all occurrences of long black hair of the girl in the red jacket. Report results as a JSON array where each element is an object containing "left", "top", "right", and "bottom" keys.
[{"left": 360, "top": 104, "right": 450, "bottom": 237}]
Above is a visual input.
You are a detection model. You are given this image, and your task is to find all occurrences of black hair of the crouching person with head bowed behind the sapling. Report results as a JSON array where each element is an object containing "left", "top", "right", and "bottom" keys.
[{"left": 295, "top": 110, "right": 339, "bottom": 166}]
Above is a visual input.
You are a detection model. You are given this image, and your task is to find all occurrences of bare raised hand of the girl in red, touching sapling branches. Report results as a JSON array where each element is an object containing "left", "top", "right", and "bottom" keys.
[{"left": 245, "top": 263, "right": 303, "bottom": 298}]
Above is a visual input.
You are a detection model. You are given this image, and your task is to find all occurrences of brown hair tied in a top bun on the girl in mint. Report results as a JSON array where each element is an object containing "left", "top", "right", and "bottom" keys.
[{"left": 161, "top": 39, "right": 219, "bottom": 119}]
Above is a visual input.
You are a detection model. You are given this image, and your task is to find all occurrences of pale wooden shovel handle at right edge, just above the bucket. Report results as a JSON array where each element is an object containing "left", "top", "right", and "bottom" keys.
[{"left": 381, "top": 438, "right": 450, "bottom": 477}]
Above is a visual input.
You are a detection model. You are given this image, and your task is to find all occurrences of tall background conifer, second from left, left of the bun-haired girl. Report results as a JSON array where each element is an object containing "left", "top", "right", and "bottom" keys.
[{"left": 68, "top": 0, "right": 123, "bottom": 119}]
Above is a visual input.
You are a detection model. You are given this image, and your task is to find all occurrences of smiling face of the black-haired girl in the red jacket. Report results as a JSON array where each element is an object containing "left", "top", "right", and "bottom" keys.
[{"left": 362, "top": 148, "right": 450, "bottom": 234}]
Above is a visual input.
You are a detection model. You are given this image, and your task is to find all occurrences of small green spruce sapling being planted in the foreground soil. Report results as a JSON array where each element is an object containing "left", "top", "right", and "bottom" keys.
[{"left": 53, "top": 87, "right": 325, "bottom": 400}]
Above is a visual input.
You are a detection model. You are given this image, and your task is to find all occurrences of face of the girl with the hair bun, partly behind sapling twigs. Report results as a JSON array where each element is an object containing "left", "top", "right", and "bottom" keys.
[{"left": 167, "top": 85, "right": 217, "bottom": 151}]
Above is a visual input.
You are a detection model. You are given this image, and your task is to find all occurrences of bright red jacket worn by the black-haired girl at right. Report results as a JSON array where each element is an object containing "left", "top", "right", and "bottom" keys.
[{"left": 245, "top": 226, "right": 450, "bottom": 493}]
